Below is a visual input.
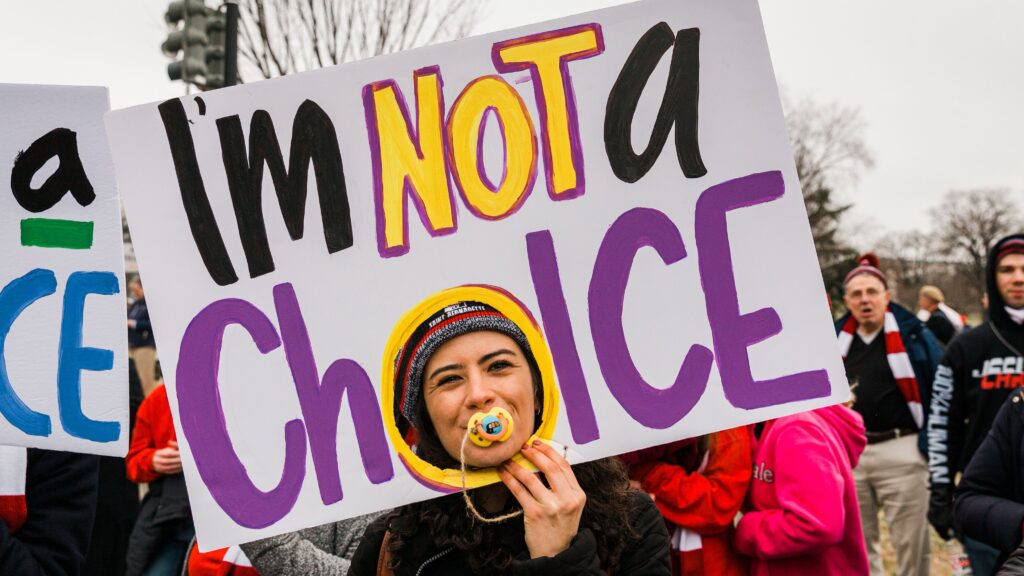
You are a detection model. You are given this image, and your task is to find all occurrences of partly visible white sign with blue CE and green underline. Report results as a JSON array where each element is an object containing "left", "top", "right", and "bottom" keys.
[{"left": 0, "top": 84, "right": 129, "bottom": 456}]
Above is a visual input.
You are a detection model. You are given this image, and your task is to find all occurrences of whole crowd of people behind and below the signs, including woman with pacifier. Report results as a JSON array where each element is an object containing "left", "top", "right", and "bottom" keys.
[{"left": 6, "top": 235, "right": 1024, "bottom": 576}]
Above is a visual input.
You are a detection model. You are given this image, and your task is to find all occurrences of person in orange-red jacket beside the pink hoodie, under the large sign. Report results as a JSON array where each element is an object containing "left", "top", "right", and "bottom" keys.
[{"left": 624, "top": 426, "right": 752, "bottom": 576}]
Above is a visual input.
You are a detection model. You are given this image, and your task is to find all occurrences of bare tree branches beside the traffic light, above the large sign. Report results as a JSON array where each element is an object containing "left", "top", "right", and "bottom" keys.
[{"left": 239, "top": 0, "right": 481, "bottom": 79}]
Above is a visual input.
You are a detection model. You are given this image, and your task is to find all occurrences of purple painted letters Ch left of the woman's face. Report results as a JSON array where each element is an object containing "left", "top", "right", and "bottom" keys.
[{"left": 176, "top": 284, "right": 394, "bottom": 528}]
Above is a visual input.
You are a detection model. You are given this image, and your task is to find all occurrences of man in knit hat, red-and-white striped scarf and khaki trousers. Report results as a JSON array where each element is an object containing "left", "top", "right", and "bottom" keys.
[{"left": 836, "top": 254, "right": 942, "bottom": 576}]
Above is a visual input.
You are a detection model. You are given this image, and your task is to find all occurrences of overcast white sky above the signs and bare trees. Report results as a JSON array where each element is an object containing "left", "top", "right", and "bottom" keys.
[{"left": 0, "top": 0, "right": 1024, "bottom": 241}]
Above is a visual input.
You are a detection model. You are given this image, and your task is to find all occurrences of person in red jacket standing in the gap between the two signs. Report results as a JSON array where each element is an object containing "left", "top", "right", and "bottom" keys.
[{"left": 125, "top": 384, "right": 196, "bottom": 576}]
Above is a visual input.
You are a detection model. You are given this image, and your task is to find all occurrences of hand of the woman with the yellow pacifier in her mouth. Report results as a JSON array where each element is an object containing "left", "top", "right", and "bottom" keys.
[{"left": 498, "top": 442, "right": 587, "bottom": 558}]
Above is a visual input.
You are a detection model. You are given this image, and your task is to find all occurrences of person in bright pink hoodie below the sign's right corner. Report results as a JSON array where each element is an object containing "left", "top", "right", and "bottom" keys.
[{"left": 735, "top": 405, "right": 868, "bottom": 576}]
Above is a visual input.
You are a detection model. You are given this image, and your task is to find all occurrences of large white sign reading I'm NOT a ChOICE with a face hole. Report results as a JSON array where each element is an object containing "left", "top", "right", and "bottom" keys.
[{"left": 108, "top": 0, "right": 848, "bottom": 548}]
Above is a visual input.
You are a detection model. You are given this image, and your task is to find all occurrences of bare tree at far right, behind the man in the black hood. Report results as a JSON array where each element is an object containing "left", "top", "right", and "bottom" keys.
[{"left": 931, "top": 188, "right": 1021, "bottom": 297}]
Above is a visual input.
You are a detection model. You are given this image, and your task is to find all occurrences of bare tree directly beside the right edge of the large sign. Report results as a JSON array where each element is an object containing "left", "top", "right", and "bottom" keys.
[{"left": 782, "top": 94, "right": 874, "bottom": 302}]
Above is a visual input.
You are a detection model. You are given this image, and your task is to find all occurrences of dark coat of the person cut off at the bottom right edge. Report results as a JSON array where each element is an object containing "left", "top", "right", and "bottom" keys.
[{"left": 953, "top": 390, "right": 1024, "bottom": 558}]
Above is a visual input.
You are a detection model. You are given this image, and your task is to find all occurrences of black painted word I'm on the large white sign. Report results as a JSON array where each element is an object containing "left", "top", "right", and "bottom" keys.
[{"left": 160, "top": 99, "right": 352, "bottom": 286}]
